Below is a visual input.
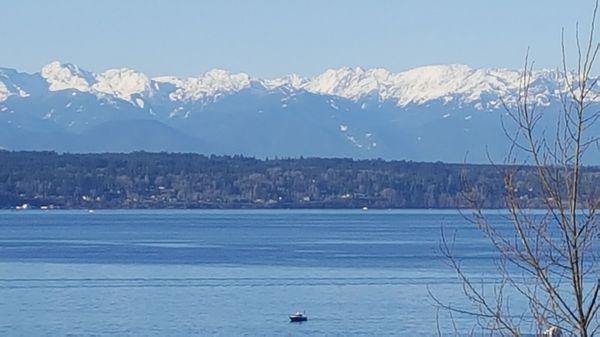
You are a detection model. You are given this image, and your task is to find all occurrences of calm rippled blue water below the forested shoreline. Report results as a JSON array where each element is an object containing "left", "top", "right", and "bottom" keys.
[{"left": 0, "top": 210, "right": 516, "bottom": 336}]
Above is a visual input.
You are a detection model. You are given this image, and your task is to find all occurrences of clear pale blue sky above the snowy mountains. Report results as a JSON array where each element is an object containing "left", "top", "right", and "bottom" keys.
[{"left": 0, "top": 0, "right": 593, "bottom": 77}]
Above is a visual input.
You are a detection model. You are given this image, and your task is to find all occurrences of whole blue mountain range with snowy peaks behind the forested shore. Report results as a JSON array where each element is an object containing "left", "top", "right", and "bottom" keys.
[{"left": 0, "top": 62, "right": 600, "bottom": 162}]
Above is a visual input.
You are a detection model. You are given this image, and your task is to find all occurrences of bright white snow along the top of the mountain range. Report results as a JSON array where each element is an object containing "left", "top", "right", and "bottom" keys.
[{"left": 10, "top": 61, "right": 572, "bottom": 108}]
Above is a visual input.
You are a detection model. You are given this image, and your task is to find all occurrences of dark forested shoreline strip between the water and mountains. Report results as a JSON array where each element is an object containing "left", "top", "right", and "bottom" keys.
[{"left": 0, "top": 151, "right": 600, "bottom": 208}]
